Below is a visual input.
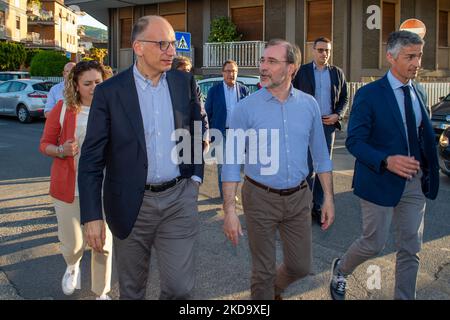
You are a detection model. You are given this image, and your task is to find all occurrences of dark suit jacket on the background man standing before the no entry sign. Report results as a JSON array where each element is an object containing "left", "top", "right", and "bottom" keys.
[{"left": 293, "top": 62, "right": 348, "bottom": 130}]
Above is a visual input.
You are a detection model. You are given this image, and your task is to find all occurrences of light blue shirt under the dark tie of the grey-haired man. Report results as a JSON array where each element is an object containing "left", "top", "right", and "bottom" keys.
[{"left": 387, "top": 70, "right": 422, "bottom": 145}]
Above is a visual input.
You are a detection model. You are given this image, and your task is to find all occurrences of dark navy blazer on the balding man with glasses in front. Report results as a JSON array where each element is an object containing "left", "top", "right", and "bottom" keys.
[{"left": 78, "top": 67, "right": 203, "bottom": 239}]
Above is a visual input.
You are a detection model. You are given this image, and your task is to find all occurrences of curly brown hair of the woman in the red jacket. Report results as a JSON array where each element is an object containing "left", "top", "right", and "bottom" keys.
[{"left": 64, "top": 60, "right": 108, "bottom": 113}]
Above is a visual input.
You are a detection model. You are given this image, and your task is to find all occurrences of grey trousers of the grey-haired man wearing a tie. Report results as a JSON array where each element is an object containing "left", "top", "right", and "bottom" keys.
[{"left": 339, "top": 173, "right": 425, "bottom": 300}]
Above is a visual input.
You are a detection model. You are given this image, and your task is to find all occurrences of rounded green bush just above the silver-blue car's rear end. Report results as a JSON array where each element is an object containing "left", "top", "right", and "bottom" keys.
[{"left": 30, "top": 50, "right": 69, "bottom": 77}]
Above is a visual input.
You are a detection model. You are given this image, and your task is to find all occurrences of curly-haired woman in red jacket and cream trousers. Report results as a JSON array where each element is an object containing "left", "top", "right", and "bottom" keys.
[{"left": 40, "top": 61, "right": 112, "bottom": 300}]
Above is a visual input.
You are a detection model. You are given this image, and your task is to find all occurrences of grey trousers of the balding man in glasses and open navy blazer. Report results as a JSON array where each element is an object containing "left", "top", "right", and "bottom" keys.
[{"left": 114, "top": 179, "right": 199, "bottom": 300}]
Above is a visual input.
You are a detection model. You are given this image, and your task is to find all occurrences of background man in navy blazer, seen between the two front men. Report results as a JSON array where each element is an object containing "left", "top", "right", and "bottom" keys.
[{"left": 205, "top": 60, "right": 249, "bottom": 199}]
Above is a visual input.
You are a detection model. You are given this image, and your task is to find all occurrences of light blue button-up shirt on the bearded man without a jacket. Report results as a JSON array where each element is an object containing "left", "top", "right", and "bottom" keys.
[{"left": 222, "top": 86, "right": 333, "bottom": 189}]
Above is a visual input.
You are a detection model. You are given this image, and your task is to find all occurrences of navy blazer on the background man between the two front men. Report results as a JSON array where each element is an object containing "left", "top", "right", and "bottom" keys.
[{"left": 205, "top": 81, "right": 249, "bottom": 134}]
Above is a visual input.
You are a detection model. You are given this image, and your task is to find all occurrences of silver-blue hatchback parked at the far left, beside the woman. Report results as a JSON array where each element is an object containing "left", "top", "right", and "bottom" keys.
[{"left": 0, "top": 79, "right": 53, "bottom": 123}]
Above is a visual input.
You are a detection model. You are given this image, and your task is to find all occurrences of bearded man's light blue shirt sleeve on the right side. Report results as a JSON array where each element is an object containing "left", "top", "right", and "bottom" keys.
[{"left": 309, "top": 99, "right": 333, "bottom": 173}]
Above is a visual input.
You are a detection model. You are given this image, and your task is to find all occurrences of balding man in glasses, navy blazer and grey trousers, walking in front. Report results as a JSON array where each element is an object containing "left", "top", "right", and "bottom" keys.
[{"left": 78, "top": 16, "right": 203, "bottom": 299}]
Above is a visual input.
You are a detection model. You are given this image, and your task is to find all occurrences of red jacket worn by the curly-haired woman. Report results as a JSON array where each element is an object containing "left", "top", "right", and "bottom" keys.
[{"left": 39, "top": 100, "right": 77, "bottom": 203}]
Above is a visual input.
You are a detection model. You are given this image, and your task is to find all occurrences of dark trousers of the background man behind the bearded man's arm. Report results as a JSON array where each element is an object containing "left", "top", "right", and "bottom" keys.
[{"left": 306, "top": 125, "right": 336, "bottom": 210}]
